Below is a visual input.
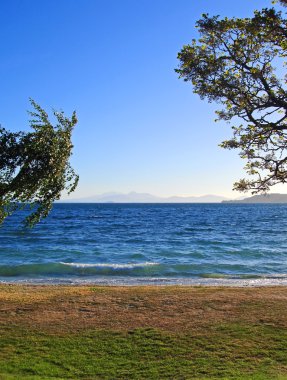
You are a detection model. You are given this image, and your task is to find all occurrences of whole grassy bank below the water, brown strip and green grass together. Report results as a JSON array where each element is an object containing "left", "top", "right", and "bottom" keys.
[{"left": 0, "top": 286, "right": 287, "bottom": 379}]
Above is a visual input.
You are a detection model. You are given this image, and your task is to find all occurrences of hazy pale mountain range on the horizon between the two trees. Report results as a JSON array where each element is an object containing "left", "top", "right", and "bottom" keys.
[{"left": 61, "top": 191, "right": 232, "bottom": 203}]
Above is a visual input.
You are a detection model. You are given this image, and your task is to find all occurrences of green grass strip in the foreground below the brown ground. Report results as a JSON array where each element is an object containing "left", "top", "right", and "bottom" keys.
[{"left": 0, "top": 323, "right": 287, "bottom": 380}]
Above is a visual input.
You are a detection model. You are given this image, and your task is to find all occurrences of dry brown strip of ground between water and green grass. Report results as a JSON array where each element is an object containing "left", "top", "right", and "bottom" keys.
[{"left": 0, "top": 285, "right": 287, "bottom": 331}]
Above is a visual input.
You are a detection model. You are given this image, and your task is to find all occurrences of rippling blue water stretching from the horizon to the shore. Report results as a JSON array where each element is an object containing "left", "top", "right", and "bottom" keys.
[{"left": 0, "top": 204, "right": 287, "bottom": 284}]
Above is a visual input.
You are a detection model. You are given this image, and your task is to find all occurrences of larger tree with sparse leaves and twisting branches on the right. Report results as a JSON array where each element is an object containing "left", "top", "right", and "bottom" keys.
[{"left": 176, "top": 6, "right": 287, "bottom": 193}]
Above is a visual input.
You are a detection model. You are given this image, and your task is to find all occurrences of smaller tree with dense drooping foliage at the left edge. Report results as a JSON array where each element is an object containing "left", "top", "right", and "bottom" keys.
[{"left": 0, "top": 100, "right": 78, "bottom": 226}]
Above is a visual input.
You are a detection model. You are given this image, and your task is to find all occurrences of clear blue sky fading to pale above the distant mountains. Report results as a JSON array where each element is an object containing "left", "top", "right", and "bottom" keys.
[{"left": 0, "top": 0, "right": 287, "bottom": 198}]
